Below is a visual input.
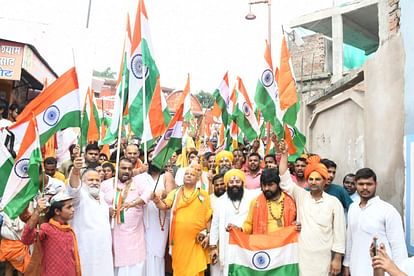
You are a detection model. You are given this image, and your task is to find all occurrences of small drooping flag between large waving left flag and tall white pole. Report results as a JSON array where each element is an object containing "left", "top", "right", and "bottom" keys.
[{"left": 81, "top": 87, "right": 101, "bottom": 146}]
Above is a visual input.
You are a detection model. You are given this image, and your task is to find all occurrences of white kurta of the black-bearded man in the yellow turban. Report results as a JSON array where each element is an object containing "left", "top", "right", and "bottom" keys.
[{"left": 210, "top": 189, "right": 261, "bottom": 276}]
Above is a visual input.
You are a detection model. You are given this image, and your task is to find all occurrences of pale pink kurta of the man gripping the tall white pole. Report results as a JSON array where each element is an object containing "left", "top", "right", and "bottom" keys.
[{"left": 101, "top": 178, "right": 151, "bottom": 267}]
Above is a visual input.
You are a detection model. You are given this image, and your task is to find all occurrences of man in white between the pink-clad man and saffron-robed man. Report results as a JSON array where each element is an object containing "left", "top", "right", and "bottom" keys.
[{"left": 138, "top": 161, "right": 175, "bottom": 276}]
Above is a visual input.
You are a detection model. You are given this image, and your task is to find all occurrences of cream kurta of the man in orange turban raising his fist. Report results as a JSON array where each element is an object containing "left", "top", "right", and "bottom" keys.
[{"left": 280, "top": 171, "right": 345, "bottom": 276}]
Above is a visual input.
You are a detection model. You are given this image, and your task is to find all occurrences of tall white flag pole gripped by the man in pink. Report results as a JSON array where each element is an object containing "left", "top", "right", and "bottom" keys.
[{"left": 111, "top": 53, "right": 126, "bottom": 228}]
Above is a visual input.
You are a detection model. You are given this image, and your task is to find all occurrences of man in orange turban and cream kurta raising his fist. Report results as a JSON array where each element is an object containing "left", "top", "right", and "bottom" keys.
[{"left": 279, "top": 141, "right": 346, "bottom": 276}]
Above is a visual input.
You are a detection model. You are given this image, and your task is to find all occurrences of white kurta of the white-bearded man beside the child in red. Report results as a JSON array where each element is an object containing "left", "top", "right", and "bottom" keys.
[{"left": 67, "top": 185, "right": 114, "bottom": 276}]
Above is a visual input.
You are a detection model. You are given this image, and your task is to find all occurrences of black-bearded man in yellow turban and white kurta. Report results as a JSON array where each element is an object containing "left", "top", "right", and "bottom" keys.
[{"left": 210, "top": 169, "right": 260, "bottom": 276}]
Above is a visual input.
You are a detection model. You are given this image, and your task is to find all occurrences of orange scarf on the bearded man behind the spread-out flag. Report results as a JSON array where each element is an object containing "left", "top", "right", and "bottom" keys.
[{"left": 253, "top": 192, "right": 296, "bottom": 234}]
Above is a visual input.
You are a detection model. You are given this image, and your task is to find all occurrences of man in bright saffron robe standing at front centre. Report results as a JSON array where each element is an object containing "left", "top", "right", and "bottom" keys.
[{"left": 153, "top": 168, "right": 212, "bottom": 276}]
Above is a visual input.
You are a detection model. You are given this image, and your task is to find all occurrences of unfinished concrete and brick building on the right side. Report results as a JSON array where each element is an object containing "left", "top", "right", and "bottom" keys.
[{"left": 290, "top": 0, "right": 414, "bottom": 254}]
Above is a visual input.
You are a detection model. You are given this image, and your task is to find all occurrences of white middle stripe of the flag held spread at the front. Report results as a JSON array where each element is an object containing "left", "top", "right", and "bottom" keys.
[{"left": 227, "top": 243, "right": 299, "bottom": 271}]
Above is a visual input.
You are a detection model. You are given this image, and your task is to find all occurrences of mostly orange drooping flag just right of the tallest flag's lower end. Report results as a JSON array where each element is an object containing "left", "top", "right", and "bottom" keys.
[{"left": 141, "top": 78, "right": 171, "bottom": 142}]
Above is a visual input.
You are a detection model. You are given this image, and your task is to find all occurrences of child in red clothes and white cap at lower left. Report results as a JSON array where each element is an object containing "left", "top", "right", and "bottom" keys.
[{"left": 22, "top": 192, "right": 81, "bottom": 276}]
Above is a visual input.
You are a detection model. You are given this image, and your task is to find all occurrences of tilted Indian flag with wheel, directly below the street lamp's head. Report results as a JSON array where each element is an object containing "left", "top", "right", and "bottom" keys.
[{"left": 233, "top": 77, "right": 259, "bottom": 140}]
